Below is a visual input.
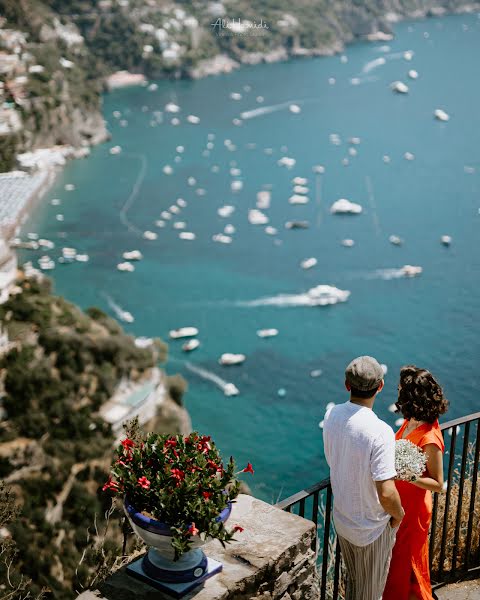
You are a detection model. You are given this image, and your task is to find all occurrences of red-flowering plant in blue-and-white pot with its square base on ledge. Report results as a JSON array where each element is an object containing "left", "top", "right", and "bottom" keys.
[{"left": 103, "top": 432, "right": 253, "bottom": 593}]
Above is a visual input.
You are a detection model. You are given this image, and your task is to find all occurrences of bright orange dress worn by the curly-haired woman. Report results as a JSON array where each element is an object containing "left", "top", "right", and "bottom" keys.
[{"left": 383, "top": 421, "right": 445, "bottom": 600}]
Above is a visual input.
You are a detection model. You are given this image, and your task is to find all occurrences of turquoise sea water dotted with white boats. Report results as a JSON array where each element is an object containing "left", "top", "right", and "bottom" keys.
[{"left": 22, "top": 15, "right": 480, "bottom": 501}]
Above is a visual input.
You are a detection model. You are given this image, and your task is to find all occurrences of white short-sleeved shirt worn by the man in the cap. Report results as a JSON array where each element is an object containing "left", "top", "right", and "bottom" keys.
[{"left": 323, "top": 402, "right": 397, "bottom": 546}]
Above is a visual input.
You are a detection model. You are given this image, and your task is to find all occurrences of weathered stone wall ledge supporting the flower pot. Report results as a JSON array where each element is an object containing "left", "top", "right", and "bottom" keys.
[{"left": 77, "top": 494, "right": 320, "bottom": 600}]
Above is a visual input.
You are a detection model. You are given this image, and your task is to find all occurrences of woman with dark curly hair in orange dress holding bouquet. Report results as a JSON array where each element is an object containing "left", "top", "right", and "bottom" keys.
[{"left": 383, "top": 365, "right": 448, "bottom": 600}]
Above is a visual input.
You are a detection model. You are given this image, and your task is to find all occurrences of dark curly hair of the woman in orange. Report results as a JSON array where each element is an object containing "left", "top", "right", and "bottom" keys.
[{"left": 395, "top": 365, "right": 448, "bottom": 423}]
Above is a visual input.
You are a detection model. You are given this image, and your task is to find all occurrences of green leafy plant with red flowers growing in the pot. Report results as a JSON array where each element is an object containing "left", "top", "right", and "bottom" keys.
[{"left": 103, "top": 432, "right": 248, "bottom": 559}]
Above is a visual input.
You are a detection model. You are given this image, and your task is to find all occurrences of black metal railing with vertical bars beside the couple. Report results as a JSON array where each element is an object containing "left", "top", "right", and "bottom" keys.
[{"left": 276, "top": 412, "right": 480, "bottom": 600}]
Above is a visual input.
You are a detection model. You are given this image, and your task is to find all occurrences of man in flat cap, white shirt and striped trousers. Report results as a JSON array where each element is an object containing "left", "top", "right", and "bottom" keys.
[{"left": 323, "top": 356, "right": 405, "bottom": 600}]
